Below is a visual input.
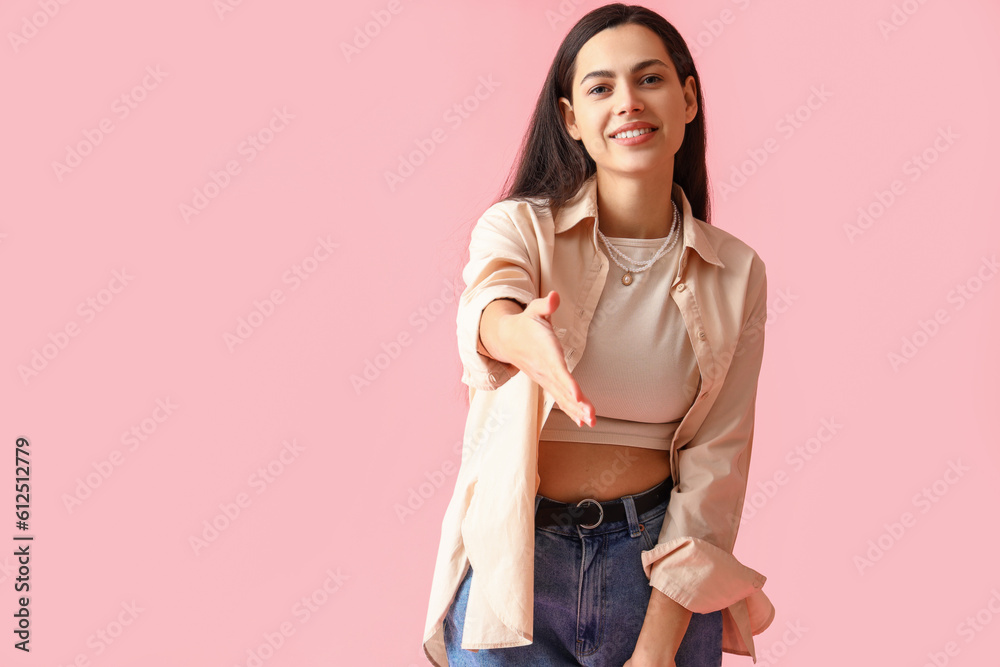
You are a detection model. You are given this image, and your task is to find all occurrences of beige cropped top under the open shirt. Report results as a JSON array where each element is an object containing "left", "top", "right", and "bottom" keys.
[{"left": 540, "top": 236, "right": 701, "bottom": 450}]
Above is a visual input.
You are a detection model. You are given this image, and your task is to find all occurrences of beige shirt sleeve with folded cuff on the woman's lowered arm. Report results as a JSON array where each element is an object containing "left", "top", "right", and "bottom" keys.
[{"left": 642, "top": 257, "right": 767, "bottom": 616}]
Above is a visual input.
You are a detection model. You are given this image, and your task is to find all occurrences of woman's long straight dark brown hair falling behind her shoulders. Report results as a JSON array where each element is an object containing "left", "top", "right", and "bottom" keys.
[{"left": 494, "top": 3, "right": 711, "bottom": 224}]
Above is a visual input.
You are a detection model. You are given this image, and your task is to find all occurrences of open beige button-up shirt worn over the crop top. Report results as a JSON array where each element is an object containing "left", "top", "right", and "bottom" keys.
[{"left": 423, "top": 176, "right": 774, "bottom": 667}]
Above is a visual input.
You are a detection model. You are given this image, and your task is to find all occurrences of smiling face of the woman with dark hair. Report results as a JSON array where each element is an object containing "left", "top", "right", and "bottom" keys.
[{"left": 559, "top": 23, "right": 698, "bottom": 175}]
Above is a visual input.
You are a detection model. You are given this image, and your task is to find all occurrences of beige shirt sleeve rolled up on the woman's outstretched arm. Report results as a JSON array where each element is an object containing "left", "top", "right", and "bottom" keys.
[{"left": 457, "top": 205, "right": 538, "bottom": 390}]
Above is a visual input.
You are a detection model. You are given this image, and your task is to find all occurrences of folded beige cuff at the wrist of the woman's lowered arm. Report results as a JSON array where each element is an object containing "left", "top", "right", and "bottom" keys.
[{"left": 642, "top": 536, "right": 767, "bottom": 614}]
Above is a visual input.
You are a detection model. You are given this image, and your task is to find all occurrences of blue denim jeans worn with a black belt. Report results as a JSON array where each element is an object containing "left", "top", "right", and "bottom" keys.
[{"left": 444, "top": 479, "right": 722, "bottom": 667}]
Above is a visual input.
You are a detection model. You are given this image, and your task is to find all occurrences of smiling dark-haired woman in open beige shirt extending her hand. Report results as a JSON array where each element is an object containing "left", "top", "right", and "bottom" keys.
[{"left": 424, "top": 4, "right": 774, "bottom": 667}]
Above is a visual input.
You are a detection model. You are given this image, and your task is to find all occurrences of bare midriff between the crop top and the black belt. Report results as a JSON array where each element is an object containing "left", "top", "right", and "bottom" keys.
[{"left": 538, "top": 440, "right": 670, "bottom": 503}]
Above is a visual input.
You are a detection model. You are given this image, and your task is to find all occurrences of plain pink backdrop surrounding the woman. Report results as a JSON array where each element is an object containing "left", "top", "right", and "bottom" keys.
[{"left": 0, "top": 0, "right": 1000, "bottom": 667}]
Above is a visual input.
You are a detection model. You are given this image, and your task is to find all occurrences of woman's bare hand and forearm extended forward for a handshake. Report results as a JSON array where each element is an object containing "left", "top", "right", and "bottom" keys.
[{"left": 498, "top": 290, "right": 596, "bottom": 426}]
